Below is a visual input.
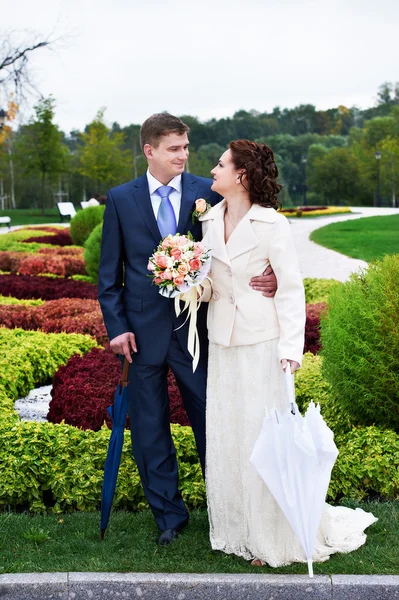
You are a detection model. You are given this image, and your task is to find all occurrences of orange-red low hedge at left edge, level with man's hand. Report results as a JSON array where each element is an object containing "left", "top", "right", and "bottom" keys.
[{"left": 0, "top": 298, "right": 108, "bottom": 344}]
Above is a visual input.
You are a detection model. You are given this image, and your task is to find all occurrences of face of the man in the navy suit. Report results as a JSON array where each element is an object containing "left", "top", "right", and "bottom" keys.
[{"left": 143, "top": 133, "right": 189, "bottom": 181}]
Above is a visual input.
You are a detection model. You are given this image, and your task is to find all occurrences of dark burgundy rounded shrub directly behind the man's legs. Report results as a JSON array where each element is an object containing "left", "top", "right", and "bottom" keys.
[{"left": 47, "top": 348, "right": 190, "bottom": 431}]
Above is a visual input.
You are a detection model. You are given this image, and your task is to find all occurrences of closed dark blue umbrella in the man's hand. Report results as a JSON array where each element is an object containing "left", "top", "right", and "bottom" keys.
[{"left": 100, "top": 358, "right": 130, "bottom": 540}]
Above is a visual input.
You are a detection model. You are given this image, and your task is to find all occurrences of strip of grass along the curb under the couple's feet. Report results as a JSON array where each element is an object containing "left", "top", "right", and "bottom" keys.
[{"left": 0, "top": 502, "right": 399, "bottom": 575}]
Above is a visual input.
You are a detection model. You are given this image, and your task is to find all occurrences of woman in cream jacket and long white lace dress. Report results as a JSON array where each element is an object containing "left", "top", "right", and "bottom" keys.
[{"left": 200, "top": 140, "right": 376, "bottom": 567}]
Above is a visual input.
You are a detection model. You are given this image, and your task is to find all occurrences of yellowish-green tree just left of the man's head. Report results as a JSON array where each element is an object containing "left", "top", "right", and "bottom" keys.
[{"left": 78, "top": 110, "right": 132, "bottom": 193}]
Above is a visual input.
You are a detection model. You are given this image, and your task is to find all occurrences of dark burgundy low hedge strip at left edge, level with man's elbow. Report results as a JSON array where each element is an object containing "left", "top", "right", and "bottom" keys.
[{"left": 0, "top": 274, "right": 97, "bottom": 300}]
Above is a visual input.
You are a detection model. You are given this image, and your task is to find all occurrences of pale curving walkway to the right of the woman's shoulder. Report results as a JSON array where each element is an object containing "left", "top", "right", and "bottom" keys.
[{"left": 290, "top": 207, "right": 399, "bottom": 281}]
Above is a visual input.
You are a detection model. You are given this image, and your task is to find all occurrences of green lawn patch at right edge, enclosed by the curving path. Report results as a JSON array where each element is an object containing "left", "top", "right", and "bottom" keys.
[{"left": 310, "top": 214, "right": 399, "bottom": 262}]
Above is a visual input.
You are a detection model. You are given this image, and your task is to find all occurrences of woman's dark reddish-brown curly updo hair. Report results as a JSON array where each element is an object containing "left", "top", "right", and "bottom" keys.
[{"left": 229, "top": 140, "right": 282, "bottom": 208}]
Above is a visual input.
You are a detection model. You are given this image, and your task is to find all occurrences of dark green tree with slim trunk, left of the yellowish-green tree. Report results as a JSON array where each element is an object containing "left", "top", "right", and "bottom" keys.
[{"left": 18, "top": 97, "right": 68, "bottom": 215}]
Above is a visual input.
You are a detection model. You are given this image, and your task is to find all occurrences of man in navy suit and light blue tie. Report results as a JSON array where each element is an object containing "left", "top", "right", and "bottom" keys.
[{"left": 98, "top": 113, "right": 276, "bottom": 545}]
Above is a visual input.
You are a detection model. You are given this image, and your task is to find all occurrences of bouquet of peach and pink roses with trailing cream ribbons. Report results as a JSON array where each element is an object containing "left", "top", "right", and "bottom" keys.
[{"left": 147, "top": 233, "right": 211, "bottom": 371}]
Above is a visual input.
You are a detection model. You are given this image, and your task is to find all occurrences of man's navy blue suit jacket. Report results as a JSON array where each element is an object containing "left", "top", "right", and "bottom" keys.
[{"left": 98, "top": 173, "right": 221, "bottom": 365}]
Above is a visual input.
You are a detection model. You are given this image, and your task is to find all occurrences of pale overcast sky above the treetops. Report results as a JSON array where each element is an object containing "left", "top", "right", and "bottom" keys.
[{"left": 0, "top": 0, "right": 399, "bottom": 132}]
